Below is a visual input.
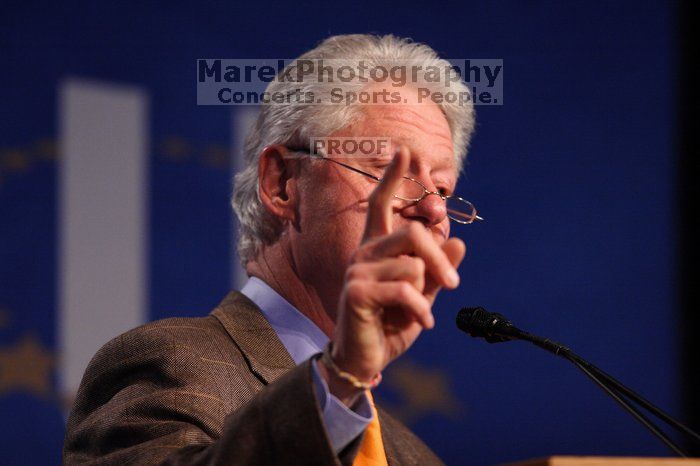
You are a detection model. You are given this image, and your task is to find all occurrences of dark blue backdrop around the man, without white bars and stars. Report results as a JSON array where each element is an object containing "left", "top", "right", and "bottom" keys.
[{"left": 0, "top": 1, "right": 682, "bottom": 465}]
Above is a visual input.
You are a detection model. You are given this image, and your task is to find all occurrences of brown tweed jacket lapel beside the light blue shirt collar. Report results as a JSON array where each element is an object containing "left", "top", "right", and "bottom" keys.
[{"left": 212, "top": 291, "right": 295, "bottom": 384}]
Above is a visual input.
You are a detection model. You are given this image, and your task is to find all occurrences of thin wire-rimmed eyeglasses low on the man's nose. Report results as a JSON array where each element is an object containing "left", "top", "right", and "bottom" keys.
[{"left": 290, "top": 148, "right": 484, "bottom": 225}]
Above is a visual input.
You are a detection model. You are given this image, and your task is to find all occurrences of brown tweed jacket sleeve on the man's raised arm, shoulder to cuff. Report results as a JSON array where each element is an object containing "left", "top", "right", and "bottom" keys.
[{"left": 63, "top": 327, "right": 361, "bottom": 465}]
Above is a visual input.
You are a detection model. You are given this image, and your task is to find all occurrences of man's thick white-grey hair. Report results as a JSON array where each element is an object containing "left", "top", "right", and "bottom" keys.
[{"left": 231, "top": 34, "right": 475, "bottom": 266}]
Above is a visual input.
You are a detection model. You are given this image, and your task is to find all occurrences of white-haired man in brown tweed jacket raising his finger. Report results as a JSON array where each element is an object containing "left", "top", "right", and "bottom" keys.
[{"left": 64, "top": 35, "right": 478, "bottom": 465}]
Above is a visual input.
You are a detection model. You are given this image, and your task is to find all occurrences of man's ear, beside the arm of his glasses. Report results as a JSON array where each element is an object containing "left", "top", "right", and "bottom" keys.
[{"left": 258, "top": 144, "right": 297, "bottom": 222}]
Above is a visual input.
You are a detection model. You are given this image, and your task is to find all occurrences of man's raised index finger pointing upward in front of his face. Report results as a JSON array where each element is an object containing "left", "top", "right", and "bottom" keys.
[{"left": 362, "top": 146, "right": 411, "bottom": 243}]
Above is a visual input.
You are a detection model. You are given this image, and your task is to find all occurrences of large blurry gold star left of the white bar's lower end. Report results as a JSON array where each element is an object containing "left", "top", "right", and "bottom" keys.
[{"left": 0, "top": 335, "right": 54, "bottom": 397}]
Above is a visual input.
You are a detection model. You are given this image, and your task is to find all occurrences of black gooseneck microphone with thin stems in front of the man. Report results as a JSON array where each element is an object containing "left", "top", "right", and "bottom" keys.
[{"left": 457, "top": 307, "right": 700, "bottom": 457}]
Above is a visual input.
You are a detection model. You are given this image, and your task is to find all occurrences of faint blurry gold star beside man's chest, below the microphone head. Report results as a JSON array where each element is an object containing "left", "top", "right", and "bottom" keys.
[{"left": 383, "top": 359, "right": 464, "bottom": 424}]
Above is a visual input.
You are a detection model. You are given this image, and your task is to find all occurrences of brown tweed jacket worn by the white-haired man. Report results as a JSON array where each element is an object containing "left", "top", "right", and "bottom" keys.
[{"left": 63, "top": 292, "right": 442, "bottom": 465}]
